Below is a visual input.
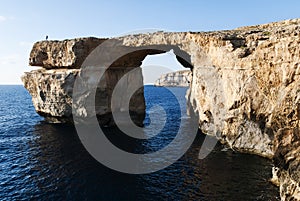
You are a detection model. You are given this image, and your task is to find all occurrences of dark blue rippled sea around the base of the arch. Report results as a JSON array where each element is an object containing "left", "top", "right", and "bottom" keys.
[{"left": 0, "top": 86, "right": 278, "bottom": 201}]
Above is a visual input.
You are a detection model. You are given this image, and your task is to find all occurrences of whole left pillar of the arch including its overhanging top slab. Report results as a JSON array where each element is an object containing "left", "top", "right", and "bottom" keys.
[{"left": 22, "top": 38, "right": 145, "bottom": 125}]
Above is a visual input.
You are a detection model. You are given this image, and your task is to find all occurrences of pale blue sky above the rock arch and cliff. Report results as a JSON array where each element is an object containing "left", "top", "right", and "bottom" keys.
[{"left": 0, "top": 0, "right": 300, "bottom": 84}]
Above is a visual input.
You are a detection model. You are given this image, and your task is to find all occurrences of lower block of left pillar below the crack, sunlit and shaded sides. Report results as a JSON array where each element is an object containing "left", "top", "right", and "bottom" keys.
[{"left": 22, "top": 68, "right": 145, "bottom": 125}]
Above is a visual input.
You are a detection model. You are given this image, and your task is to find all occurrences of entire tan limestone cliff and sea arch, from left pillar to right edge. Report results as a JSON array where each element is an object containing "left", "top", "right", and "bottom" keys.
[{"left": 22, "top": 19, "right": 300, "bottom": 200}]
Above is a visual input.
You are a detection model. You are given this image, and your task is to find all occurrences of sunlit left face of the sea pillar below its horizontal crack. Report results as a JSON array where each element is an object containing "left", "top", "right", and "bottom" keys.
[{"left": 22, "top": 69, "right": 79, "bottom": 122}]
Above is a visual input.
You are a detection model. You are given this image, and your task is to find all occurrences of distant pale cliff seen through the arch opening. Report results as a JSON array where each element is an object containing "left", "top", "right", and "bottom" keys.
[{"left": 154, "top": 70, "right": 192, "bottom": 87}]
